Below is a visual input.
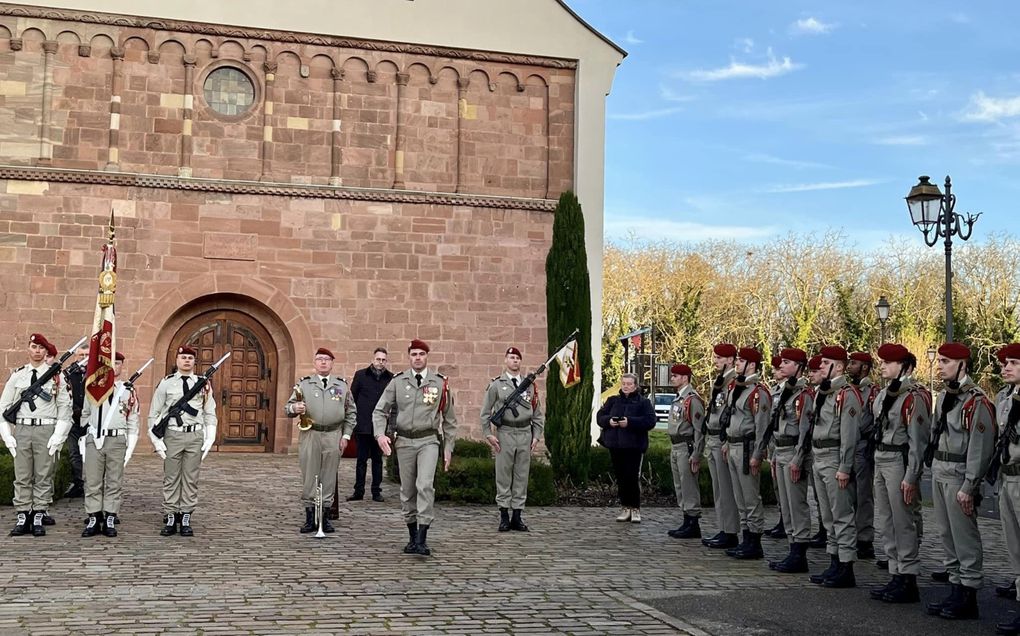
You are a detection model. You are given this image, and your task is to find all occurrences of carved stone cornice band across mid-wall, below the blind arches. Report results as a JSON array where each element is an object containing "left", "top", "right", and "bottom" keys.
[{"left": 0, "top": 165, "right": 556, "bottom": 212}]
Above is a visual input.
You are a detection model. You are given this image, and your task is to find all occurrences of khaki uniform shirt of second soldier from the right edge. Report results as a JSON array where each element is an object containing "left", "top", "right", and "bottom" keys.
[{"left": 931, "top": 376, "right": 996, "bottom": 494}]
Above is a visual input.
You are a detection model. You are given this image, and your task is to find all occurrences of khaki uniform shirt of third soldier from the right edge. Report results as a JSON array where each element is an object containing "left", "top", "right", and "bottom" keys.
[{"left": 871, "top": 377, "right": 931, "bottom": 485}]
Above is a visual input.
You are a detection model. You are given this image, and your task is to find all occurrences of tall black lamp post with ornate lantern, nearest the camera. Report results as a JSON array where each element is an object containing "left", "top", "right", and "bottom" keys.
[{"left": 907, "top": 175, "right": 981, "bottom": 342}]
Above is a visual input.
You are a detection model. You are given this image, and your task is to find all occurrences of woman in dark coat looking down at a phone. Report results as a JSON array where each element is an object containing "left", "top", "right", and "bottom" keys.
[{"left": 596, "top": 373, "right": 655, "bottom": 523}]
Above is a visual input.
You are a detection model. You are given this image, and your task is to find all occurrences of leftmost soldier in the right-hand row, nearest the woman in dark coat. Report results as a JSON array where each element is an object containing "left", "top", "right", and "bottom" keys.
[{"left": 667, "top": 364, "right": 705, "bottom": 539}]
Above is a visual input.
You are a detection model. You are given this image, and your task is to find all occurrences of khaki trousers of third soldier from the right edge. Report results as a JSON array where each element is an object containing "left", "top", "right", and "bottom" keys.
[{"left": 875, "top": 451, "right": 921, "bottom": 576}]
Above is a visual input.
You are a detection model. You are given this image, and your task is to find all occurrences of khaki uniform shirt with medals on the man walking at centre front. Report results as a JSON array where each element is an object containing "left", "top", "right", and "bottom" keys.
[{"left": 372, "top": 369, "right": 457, "bottom": 452}]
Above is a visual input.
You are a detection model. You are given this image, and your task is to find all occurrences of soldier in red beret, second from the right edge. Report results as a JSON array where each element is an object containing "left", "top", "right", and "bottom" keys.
[{"left": 925, "top": 342, "right": 996, "bottom": 619}]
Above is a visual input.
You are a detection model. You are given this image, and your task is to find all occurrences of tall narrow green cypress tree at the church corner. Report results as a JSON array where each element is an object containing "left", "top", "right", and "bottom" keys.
[{"left": 546, "top": 191, "right": 594, "bottom": 485}]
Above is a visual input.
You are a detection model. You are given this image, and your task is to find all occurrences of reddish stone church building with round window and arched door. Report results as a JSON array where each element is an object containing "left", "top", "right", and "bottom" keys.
[{"left": 0, "top": 0, "right": 624, "bottom": 453}]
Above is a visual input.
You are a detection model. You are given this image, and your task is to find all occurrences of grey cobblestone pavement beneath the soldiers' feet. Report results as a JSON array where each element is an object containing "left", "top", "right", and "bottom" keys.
[{"left": 0, "top": 454, "right": 1016, "bottom": 635}]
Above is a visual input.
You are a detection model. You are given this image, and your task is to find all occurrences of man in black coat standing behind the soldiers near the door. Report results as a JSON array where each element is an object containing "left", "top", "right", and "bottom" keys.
[{"left": 347, "top": 347, "right": 393, "bottom": 501}]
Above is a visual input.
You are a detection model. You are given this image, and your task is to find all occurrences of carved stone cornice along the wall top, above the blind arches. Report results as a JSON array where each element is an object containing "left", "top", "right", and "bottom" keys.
[{"left": 0, "top": 3, "right": 577, "bottom": 68}]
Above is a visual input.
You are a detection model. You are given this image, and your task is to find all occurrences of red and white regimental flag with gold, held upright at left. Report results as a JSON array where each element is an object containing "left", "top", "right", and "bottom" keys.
[{"left": 85, "top": 211, "right": 117, "bottom": 406}]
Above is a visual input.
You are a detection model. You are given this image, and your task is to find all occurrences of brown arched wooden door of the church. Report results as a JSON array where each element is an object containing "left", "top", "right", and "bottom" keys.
[{"left": 166, "top": 310, "right": 276, "bottom": 453}]
